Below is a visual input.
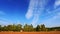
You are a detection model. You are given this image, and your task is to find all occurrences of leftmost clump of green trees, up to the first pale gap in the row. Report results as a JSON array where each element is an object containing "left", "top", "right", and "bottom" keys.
[{"left": 0, "top": 24, "right": 22, "bottom": 31}]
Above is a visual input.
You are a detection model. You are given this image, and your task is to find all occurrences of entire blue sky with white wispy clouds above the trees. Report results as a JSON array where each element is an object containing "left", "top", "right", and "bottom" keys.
[{"left": 0, "top": 0, "right": 60, "bottom": 27}]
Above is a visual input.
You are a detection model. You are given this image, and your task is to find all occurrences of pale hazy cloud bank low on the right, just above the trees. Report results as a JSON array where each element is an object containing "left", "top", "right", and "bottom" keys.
[{"left": 40, "top": 8, "right": 60, "bottom": 27}]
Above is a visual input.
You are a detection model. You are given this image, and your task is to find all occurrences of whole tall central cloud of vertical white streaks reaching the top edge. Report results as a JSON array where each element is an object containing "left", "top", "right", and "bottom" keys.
[{"left": 26, "top": 0, "right": 48, "bottom": 25}]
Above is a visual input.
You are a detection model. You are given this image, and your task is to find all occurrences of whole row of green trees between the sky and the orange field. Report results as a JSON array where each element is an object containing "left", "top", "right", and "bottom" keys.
[{"left": 0, "top": 24, "right": 60, "bottom": 32}]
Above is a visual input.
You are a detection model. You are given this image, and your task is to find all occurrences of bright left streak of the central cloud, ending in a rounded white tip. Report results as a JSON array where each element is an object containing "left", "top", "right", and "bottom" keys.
[{"left": 25, "top": 0, "right": 35, "bottom": 19}]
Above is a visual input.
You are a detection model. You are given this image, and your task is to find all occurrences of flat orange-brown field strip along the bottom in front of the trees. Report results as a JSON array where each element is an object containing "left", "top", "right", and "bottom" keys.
[{"left": 0, "top": 31, "right": 60, "bottom": 34}]
